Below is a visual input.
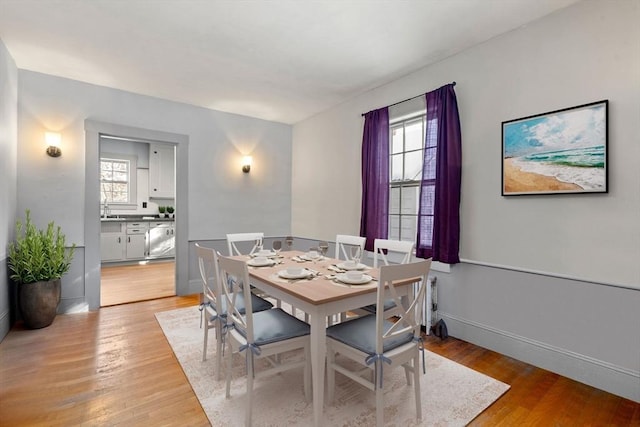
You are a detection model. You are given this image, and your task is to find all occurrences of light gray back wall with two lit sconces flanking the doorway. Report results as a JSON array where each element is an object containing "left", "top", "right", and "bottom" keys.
[{"left": 17, "top": 70, "right": 291, "bottom": 311}]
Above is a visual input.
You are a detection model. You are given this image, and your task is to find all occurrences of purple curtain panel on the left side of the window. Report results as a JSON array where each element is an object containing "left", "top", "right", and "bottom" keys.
[{"left": 360, "top": 107, "right": 389, "bottom": 251}]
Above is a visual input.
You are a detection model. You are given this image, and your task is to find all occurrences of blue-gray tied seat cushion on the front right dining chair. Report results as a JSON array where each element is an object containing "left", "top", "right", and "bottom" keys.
[{"left": 327, "top": 314, "right": 413, "bottom": 355}]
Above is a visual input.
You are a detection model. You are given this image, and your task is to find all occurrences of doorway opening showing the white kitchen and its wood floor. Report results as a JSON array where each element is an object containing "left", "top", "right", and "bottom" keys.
[{"left": 99, "top": 133, "right": 176, "bottom": 307}]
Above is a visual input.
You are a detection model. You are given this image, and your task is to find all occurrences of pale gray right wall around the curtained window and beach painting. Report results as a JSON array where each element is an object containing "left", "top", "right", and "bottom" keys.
[{"left": 292, "top": 0, "right": 640, "bottom": 401}]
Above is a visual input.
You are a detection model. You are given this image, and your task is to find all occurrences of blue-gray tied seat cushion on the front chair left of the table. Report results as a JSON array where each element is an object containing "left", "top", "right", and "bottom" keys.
[{"left": 236, "top": 308, "right": 310, "bottom": 346}]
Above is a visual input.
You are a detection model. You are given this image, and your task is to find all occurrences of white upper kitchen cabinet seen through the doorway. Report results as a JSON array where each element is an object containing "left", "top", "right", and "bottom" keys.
[{"left": 149, "top": 144, "right": 176, "bottom": 199}]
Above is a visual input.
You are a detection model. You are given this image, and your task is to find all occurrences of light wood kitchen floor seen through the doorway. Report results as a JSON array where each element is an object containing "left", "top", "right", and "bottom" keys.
[{"left": 100, "top": 261, "right": 176, "bottom": 307}]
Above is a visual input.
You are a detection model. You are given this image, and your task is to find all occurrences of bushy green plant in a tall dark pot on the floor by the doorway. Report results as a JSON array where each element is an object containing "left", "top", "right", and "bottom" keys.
[{"left": 9, "top": 209, "right": 76, "bottom": 329}]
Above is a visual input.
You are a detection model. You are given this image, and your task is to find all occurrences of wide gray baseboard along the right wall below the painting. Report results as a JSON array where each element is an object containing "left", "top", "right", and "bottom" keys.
[{"left": 438, "top": 311, "right": 640, "bottom": 403}]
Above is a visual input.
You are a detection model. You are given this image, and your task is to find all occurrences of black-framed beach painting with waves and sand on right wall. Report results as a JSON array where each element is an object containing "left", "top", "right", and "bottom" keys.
[{"left": 502, "top": 100, "right": 608, "bottom": 196}]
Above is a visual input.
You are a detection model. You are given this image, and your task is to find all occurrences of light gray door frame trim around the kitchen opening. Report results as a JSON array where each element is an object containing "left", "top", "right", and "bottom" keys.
[{"left": 84, "top": 119, "right": 189, "bottom": 310}]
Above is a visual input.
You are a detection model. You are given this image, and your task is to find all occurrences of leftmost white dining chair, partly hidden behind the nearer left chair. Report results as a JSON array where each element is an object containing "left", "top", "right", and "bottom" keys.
[{"left": 195, "top": 243, "right": 273, "bottom": 380}]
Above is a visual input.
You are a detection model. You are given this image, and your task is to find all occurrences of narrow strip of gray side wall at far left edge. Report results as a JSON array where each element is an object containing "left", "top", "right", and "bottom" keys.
[{"left": 0, "top": 40, "right": 18, "bottom": 341}]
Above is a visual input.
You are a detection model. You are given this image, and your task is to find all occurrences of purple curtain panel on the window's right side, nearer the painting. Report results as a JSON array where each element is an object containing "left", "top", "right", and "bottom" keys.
[{"left": 416, "top": 83, "right": 462, "bottom": 264}]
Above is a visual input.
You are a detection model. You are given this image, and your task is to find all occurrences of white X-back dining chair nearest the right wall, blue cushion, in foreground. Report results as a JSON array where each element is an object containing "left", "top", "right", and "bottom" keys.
[{"left": 327, "top": 259, "right": 431, "bottom": 427}]
